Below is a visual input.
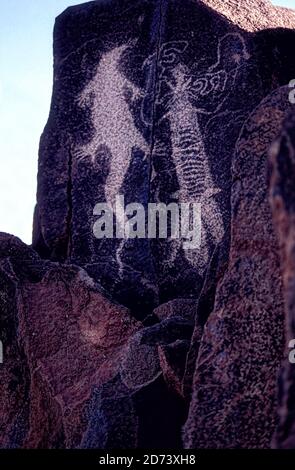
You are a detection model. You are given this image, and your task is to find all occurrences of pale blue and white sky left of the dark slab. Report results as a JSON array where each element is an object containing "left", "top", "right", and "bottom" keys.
[{"left": 0, "top": 0, "right": 295, "bottom": 243}]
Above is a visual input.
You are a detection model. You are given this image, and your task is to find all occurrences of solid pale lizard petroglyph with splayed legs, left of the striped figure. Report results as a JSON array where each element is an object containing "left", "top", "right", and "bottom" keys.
[{"left": 79, "top": 44, "right": 149, "bottom": 204}]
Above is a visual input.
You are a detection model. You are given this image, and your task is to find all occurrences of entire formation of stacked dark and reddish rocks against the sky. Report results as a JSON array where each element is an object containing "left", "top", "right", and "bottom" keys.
[{"left": 0, "top": 0, "right": 295, "bottom": 449}]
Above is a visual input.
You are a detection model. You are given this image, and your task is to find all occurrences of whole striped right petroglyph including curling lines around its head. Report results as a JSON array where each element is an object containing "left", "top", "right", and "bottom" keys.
[{"left": 155, "top": 34, "right": 250, "bottom": 272}]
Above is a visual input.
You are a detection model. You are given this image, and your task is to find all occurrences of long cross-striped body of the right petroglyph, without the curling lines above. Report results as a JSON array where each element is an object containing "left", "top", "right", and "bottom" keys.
[{"left": 169, "top": 66, "right": 224, "bottom": 272}]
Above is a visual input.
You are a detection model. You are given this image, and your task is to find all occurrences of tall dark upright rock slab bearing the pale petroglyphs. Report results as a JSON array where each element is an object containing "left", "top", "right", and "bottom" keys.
[{"left": 33, "top": 0, "right": 295, "bottom": 317}]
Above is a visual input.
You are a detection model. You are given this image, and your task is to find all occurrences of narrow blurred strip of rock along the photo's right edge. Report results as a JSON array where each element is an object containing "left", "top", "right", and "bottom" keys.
[{"left": 271, "top": 106, "right": 295, "bottom": 449}]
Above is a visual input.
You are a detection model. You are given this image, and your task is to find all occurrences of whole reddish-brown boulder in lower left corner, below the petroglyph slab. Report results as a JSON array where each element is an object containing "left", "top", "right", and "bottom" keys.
[{"left": 0, "top": 234, "right": 140, "bottom": 448}]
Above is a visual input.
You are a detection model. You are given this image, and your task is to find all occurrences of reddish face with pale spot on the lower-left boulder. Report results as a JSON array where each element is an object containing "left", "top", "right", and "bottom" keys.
[{"left": 21, "top": 267, "right": 140, "bottom": 448}]
